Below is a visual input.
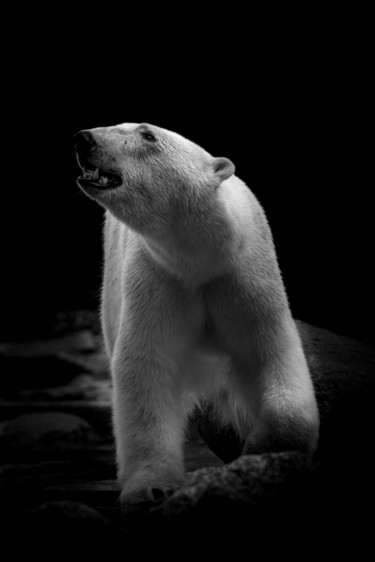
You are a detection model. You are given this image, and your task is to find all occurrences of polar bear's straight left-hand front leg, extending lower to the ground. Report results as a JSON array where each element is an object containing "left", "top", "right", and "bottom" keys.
[{"left": 112, "top": 339, "right": 184, "bottom": 503}]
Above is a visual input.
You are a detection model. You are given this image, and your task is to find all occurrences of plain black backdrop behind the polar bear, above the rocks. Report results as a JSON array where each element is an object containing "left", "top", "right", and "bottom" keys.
[{"left": 1, "top": 14, "right": 375, "bottom": 343}]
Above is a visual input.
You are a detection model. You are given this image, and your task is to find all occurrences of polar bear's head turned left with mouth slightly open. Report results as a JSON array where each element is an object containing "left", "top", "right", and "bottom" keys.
[{"left": 74, "top": 123, "right": 234, "bottom": 236}]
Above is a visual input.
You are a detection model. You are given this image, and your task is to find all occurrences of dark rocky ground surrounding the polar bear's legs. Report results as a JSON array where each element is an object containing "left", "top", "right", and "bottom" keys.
[{"left": 0, "top": 312, "right": 375, "bottom": 557}]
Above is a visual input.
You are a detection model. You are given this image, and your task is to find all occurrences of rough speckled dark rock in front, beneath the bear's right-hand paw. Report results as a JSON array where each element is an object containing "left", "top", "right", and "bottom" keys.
[{"left": 146, "top": 452, "right": 324, "bottom": 559}]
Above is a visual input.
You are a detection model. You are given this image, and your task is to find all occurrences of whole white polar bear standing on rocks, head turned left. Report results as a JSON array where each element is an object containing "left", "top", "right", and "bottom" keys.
[{"left": 75, "top": 123, "right": 319, "bottom": 504}]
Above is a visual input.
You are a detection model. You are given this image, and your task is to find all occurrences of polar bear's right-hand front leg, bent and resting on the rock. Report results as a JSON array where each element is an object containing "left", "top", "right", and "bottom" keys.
[{"left": 207, "top": 278, "right": 319, "bottom": 456}]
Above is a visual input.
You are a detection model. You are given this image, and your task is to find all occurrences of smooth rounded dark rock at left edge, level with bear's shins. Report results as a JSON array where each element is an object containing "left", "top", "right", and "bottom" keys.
[{"left": 0, "top": 412, "right": 97, "bottom": 455}]
